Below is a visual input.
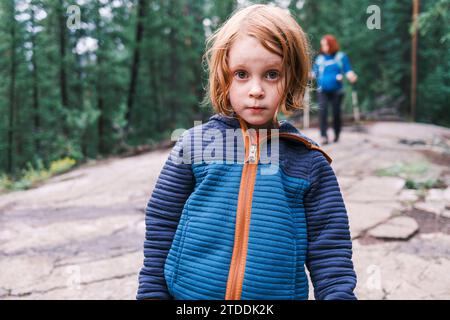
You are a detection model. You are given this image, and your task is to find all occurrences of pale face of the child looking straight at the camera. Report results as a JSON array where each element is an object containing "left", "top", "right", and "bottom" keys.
[{"left": 228, "top": 36, "right": 284, "bottom": 128}]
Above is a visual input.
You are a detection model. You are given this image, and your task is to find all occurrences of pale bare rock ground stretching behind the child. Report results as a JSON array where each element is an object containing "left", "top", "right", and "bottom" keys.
[{"left": 0, "top": 123, "right": 450, "bottom": 299}]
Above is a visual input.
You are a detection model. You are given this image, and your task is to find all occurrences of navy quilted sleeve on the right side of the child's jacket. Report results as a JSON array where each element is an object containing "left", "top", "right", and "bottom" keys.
[{"left": 304, "top": 150, "right": 356, "bottom": 300}]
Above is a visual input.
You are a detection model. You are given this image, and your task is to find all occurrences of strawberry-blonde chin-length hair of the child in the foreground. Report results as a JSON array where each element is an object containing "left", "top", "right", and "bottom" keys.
[{"left": 202, "top": 4, "right": 311, "bottom": 116}]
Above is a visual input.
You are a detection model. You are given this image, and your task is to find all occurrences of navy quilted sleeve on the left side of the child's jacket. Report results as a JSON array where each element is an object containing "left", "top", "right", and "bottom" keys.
[{"left": 136, "top": 136, "right": 194, "bottom": 300}]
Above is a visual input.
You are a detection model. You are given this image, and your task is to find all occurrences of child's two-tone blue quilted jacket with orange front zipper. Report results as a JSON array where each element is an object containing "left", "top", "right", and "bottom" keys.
[{"left": 137, "top": 114, "right": 356, "bottom": 300}]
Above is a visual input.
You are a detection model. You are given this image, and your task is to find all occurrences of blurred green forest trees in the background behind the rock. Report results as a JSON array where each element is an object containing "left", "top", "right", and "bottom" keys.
[{"left": 0, "top": 0, "right": 450, "bottom": 178}]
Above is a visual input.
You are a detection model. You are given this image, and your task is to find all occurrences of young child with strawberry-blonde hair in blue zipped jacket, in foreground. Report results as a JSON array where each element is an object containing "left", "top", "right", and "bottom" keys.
[{"left": 137, "top": 5, "right": 356, "bottom": 300}]
